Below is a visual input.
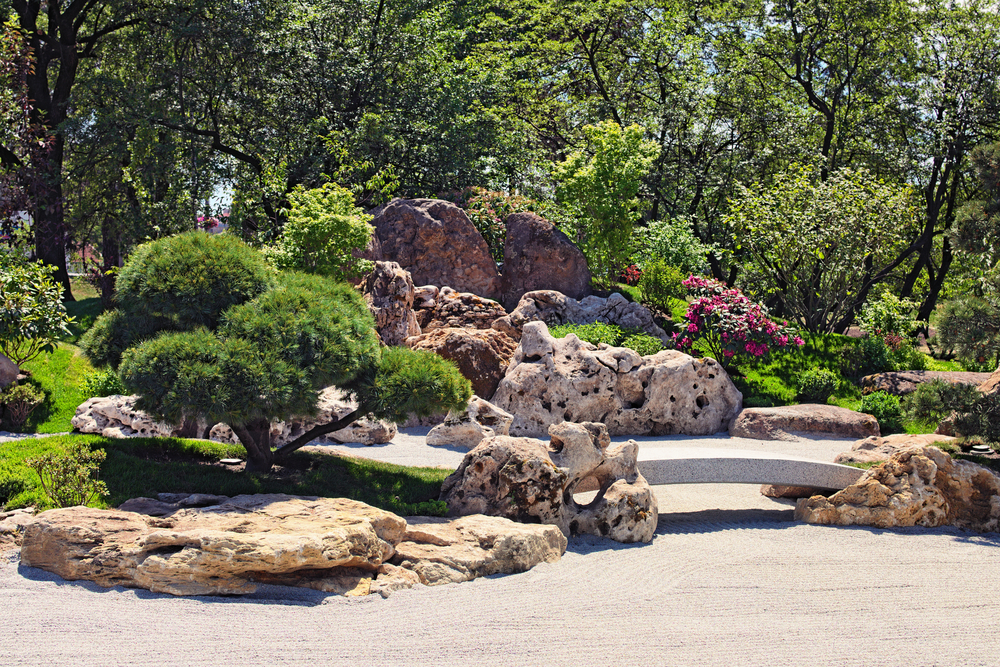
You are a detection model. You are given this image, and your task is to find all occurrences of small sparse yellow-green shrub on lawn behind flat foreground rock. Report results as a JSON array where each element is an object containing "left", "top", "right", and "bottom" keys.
[{"left": 26, "top": 442, "right": 108, "bottom": 507}]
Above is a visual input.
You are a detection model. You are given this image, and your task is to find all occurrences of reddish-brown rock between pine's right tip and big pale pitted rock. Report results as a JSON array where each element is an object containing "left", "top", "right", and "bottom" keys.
[{"left": 406, "top": 328, "right": 517, "bottom": 399}]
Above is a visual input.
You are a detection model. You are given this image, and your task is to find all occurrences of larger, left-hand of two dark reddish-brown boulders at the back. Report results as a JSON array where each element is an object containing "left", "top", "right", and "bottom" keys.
[{"left": 367, "top": 199, "right": 500, "bottom": 299}]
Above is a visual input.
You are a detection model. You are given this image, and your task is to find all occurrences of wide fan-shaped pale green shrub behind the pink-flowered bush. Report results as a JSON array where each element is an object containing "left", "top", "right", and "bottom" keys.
[{"left": 726, "top": 167, "right": 917, "bottom": 333}]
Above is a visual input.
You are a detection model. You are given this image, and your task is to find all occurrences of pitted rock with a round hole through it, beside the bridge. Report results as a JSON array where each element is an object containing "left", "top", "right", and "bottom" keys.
[{"left": 441, "top": 423, "right": 657, "bottom": 542}]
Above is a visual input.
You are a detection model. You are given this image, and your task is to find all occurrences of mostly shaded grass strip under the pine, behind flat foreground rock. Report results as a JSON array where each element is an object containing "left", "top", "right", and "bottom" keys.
[{"left": 0, "top": 435, "right": 451, "bottom": 515}]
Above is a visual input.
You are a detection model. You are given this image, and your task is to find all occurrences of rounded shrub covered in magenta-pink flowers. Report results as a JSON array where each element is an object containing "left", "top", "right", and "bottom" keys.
[{"left": 674, "top": 276, "right": 805, "bottom": 369}]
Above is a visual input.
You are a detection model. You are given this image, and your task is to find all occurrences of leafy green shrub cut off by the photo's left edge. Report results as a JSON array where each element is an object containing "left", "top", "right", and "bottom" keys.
[{"left": 0, "top": 249, "right": 73, "bottom": 366}]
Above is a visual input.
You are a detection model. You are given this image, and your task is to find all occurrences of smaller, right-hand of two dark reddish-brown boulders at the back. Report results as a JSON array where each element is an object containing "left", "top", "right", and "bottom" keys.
[{"left": 500, "top": 213, "right": 590, "bottom": 310}]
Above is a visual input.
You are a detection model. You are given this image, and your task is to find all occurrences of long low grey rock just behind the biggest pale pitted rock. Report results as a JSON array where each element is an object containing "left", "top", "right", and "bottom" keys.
[{"left": 493, "top": 290, "right": 671, "bottom": 343}]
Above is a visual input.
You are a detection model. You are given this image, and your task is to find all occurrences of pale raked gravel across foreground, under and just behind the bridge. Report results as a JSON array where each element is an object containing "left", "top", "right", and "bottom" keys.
[{"left": 0, "top": 430, "right": 1000, "bottom": 667}]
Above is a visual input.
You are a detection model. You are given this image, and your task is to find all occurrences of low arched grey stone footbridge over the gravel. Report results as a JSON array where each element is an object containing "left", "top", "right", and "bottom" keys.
[{"left": 638, "top": 447, "right": 865, "bottom": 489}]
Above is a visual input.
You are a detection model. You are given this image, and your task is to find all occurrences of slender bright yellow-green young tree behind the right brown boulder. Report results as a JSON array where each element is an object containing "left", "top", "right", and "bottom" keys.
[{"left": 552, "top": 121, "right": 660, "bottom": 285}]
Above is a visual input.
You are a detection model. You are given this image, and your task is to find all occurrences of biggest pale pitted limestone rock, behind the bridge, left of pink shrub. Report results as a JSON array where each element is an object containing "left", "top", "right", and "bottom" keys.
[{"left": 492, "top": 322, "right": 743, "bottom": 437}]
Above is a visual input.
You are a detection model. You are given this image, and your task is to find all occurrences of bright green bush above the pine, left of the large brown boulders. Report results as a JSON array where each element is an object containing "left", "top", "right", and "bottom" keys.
[{"left": 266, "top": 183, "right": 375, "bottom": 280}]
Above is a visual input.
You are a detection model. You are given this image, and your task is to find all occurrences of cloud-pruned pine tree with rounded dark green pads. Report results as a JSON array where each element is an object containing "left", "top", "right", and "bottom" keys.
[{"left": 82, "top": 232, "right": 472, "bottom": 472}]
